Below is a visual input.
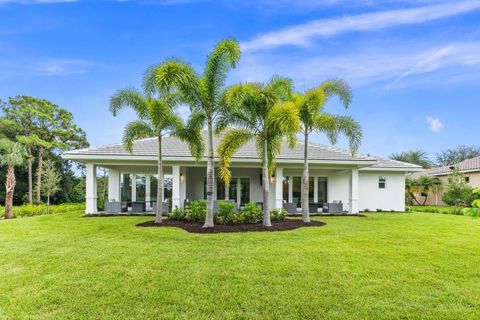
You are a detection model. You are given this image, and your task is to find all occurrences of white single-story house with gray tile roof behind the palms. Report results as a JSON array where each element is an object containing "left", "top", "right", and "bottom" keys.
[{"left": 63, "top": 132, "right": 421, "bottom": 214}]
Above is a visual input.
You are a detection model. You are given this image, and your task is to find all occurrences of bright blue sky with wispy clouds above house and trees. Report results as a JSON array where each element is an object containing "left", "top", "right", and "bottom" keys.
[{"left": 0, "top": 0, "right": 480, "bottom": 157}]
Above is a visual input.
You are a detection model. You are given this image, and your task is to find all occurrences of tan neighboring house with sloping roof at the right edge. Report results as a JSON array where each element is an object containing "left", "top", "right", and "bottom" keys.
[{"left": 411, "top": 157, "right": 480, "bottom": 206}]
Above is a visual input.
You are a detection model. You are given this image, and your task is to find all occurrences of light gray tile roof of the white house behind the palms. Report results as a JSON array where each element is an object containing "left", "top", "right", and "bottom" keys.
[{"left": 64, "top": 131, "right": 419, "bottom": 170}]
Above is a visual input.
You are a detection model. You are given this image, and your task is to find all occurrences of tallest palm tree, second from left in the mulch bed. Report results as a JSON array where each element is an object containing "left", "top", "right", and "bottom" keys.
[{"left": 145, "top": 39, "right": 240, "bottom": 227}]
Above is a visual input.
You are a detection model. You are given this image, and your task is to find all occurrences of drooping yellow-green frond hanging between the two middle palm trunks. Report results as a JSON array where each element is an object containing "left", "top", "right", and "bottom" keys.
[{"left": 217, "top": 129, "right": 254, "bottom": 184}]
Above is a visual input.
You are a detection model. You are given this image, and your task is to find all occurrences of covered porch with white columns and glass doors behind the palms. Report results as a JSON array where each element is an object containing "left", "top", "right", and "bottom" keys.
[{"left": 86, "top": 162, "right": 359, "bottom": 214}]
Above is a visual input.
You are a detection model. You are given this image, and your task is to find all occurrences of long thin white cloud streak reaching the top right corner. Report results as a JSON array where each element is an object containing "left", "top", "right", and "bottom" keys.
[{"left": 242, "top": 0, "right": 480, "bottom": 50}]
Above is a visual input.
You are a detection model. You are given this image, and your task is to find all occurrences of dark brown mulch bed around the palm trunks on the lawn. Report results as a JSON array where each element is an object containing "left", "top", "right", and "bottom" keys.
[{"left": 137, "top": 219, "right": 326, "bottom": 233}]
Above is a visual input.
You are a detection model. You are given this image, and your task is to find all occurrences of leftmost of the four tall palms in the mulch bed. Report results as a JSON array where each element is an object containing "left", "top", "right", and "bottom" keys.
[{"left": 110, "top": 89, "right": 199, "bottom": 223}]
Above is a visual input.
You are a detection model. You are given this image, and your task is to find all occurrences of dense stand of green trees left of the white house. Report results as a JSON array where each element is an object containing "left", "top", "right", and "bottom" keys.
[{"left": 0, "top": 96, "right": 88, "bottom": 216}]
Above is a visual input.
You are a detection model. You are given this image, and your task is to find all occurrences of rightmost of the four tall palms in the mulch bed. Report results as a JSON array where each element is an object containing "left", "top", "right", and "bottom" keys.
[{"left": 292, "top": 79, "right": 362, "bottom": 222}]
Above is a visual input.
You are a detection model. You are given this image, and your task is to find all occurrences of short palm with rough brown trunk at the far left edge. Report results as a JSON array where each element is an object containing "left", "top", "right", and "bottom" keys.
[{"left": 0, "top": 139, "right": 27, "bottom": 219}]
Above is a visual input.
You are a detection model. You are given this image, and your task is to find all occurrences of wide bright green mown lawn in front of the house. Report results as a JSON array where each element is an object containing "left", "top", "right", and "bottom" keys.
[{"left": 0, "top": 212, "right": 480, "bottom": 319}]
